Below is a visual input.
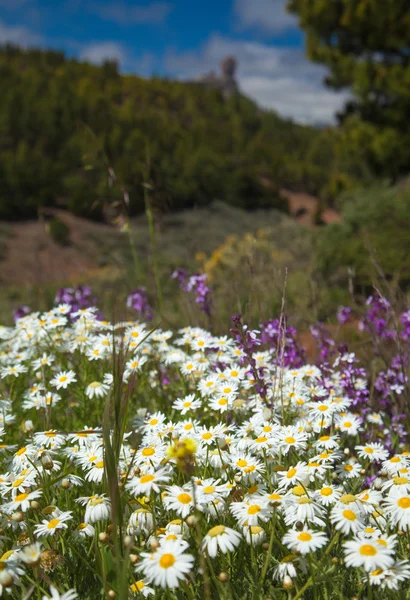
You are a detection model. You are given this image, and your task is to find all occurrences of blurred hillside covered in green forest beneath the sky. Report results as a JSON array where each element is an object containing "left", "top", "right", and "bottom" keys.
[{"left": 0, "top": 45, "right": 340, "bottom": 220}]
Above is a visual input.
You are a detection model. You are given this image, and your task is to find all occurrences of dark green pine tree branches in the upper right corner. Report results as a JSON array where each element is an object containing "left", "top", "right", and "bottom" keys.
[{"left": 288, "top": 0, "right": 410, "bottom": 178}]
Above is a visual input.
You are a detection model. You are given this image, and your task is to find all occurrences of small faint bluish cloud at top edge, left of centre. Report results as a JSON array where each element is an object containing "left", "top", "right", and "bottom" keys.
[{"left": 89, "top": 2, "right": 173, "bottom": 25}]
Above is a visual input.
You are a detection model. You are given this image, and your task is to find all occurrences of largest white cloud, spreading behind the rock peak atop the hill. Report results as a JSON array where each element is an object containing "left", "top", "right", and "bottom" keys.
[{"left": 165, "top": 35, "right": 347, "bottom": 123}]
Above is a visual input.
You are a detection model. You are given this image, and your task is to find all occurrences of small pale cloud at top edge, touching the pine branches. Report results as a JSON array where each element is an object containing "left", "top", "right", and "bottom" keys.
[{"left": 234, "top": 0, "right": 297, "bottom": 33}]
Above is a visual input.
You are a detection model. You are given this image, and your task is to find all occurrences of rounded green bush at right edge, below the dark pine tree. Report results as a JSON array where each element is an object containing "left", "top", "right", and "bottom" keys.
[{"left": 316, "top": 183, "right": 410, "bottom": 287}]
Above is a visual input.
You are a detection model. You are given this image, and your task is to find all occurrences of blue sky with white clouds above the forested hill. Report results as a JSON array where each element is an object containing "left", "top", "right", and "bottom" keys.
[{"left": 0, "top": 0, "right": 345, "bottom": 122}]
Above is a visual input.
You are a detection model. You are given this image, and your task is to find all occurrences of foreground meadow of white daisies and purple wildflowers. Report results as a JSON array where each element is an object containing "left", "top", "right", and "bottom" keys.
[{"left": 0, "top": 282, "right": 410, "bottom": 600}]
